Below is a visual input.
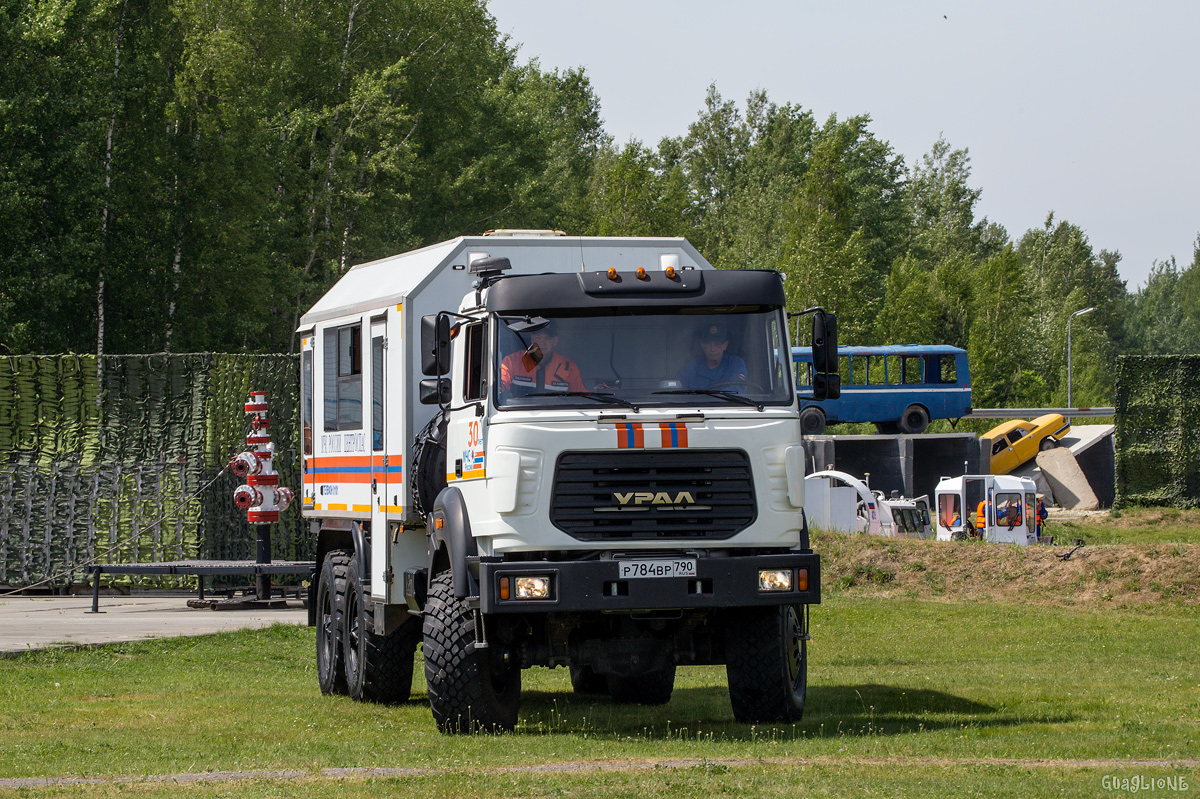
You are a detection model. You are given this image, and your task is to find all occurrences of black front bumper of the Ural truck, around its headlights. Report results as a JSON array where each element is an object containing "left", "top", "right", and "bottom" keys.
[{"left": 479, "top": 552, "right": 821, "bottom": 613}]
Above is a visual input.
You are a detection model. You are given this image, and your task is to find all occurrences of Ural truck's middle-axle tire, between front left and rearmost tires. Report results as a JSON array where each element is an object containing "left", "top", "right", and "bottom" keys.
[{"left": 342, "top": 558, "right": 421, "bottom": 703}]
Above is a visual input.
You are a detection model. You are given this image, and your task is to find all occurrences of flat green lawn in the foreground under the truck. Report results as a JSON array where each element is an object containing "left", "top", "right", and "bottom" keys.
[{"left": 0, "top": 595, "right": 1200, "bottom": 797}]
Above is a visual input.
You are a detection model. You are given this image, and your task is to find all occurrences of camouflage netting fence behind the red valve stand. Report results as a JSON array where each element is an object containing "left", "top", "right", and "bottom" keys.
[{"left": 0, "top": 353, "right": 304, "bottom": 587}]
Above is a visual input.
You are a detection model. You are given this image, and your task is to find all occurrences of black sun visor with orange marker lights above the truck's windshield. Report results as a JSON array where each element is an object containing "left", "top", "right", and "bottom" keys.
[{"left": 487, "top": 270, "right": 785, "bottom": 313}]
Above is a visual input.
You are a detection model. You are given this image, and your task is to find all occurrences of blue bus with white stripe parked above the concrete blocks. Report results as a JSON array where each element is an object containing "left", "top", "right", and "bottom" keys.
[{"left": 792, "top": 344, "right": 971, "bottom": 435}]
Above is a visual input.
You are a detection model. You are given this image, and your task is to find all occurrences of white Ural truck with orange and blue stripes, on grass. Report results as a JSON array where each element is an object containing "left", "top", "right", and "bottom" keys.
[{"left": 299, "top": 230, "right": 836, "bottom": 732}]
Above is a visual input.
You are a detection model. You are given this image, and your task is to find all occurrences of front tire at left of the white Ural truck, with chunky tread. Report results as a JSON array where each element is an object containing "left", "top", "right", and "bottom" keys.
[{"left": 424, "top": 572, "right": 521, "bottom": 733}]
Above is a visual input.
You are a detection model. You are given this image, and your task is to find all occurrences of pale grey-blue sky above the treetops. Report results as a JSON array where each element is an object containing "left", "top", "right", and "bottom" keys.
[{"left": 488, "top": 0, "right": 1200, "bottom": 290}]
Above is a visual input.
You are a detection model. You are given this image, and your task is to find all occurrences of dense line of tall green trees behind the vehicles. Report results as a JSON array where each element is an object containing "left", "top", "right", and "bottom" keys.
[{"left": 0, "top": 0, "right": 1200, "bottom": 407}]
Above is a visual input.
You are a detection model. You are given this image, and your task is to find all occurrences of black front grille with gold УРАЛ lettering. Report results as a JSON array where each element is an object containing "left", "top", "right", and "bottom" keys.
[{"left": 550, "top": 450, "right": 757, "bottom": 541}]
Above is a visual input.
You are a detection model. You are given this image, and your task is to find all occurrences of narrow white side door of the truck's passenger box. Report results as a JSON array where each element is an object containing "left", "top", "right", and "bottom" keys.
[{"left": 367, "top": 316, "right": 388, "bottom": 601}]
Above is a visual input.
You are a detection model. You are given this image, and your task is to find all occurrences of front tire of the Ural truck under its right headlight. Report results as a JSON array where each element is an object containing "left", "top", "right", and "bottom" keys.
[{"left": 725, "top": 605, "right": 809, "bottom": 723}]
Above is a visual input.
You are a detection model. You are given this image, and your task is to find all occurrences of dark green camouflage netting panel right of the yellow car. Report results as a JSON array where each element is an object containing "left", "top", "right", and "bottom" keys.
[{"left": 1115, "top": 355, "right": 1200, "bottom": 507}]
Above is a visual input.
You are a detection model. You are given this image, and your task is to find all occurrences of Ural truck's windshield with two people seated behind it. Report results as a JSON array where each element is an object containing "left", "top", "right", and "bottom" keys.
[{"left": 493, "top": 303, "right": 796, "bottom": 409}]
